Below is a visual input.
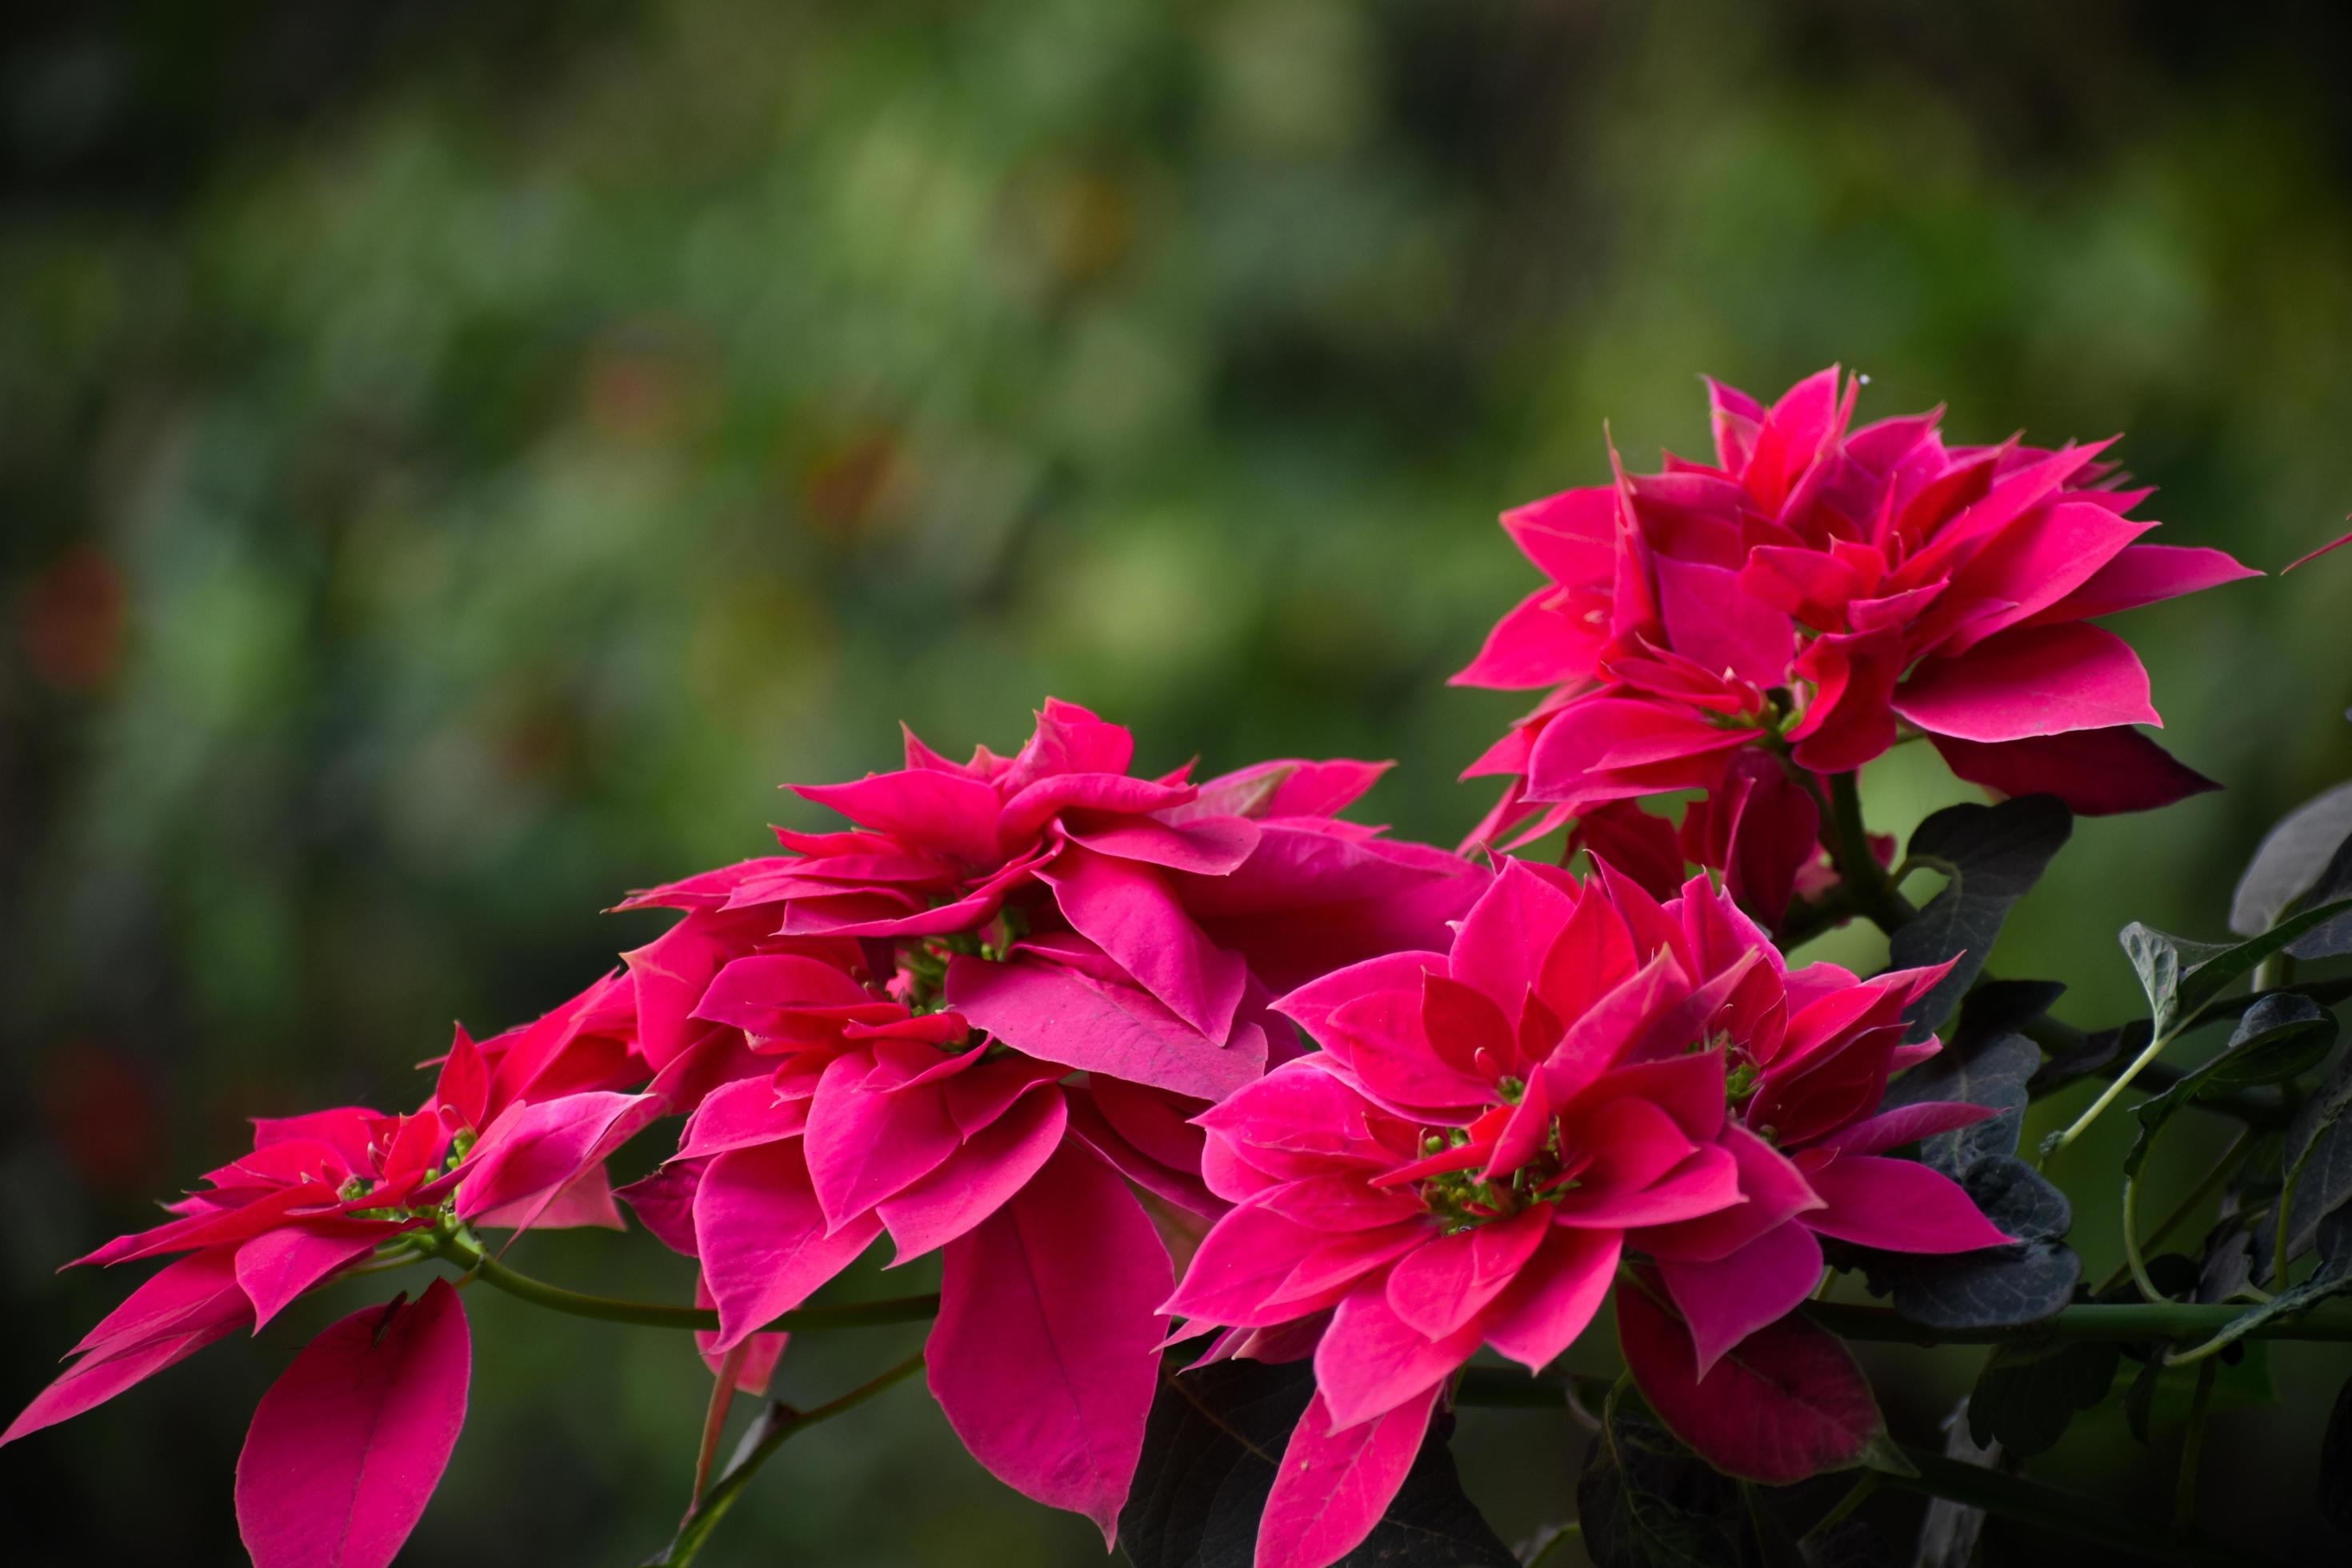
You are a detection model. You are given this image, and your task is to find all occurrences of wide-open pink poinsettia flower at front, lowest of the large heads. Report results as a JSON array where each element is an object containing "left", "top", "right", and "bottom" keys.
[{"left": 1169, "top": 861, "right": 2006, "bottom": 1568}]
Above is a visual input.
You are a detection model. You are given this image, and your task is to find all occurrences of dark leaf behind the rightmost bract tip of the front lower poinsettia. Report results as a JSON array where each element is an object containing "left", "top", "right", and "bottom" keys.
[{"left": 1862, "top": 1154, "right": 2082, "bottom": 1328}]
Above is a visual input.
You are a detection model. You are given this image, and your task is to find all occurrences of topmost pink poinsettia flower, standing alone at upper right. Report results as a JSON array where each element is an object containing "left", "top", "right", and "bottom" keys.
[{"left": 1454, "top": 366, "right": 2258, "bottom": 837}]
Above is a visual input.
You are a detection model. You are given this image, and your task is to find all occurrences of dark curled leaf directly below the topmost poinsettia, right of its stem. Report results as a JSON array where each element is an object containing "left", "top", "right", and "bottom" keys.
[{"left": 1886, "top": 794, "right": 2074, "bottom": 1039}]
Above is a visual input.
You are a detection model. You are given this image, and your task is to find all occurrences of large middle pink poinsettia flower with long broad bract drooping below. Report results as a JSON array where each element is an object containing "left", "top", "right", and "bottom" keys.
[{"left": 588, "top": 701, "right": 1486, "bottom": 1540}]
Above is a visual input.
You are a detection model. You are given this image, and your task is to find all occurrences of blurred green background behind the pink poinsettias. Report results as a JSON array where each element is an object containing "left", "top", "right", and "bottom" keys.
[{"left": 0, "top": 0, "right": 2352, "bottom": 1566}]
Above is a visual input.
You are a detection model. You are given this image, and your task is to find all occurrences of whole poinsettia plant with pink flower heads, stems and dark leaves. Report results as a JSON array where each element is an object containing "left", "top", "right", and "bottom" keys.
[{"left": 14, "top": 369, "right": 2352, "bottom": 1568}]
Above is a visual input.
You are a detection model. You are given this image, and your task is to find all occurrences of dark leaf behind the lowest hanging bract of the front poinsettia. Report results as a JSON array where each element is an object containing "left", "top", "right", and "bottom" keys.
[{"left": 1119, "top": 1361, "right": 1517, "bottom": 1568}]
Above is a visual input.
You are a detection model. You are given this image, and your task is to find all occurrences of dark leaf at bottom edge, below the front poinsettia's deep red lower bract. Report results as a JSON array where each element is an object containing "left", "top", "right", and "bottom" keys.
[{"left": 1576, "top": 1394, "right": 1754, "bottom": 1568}]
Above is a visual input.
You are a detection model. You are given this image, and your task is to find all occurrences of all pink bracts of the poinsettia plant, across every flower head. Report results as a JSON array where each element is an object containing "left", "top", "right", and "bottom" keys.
[{"left": 0, "top": 371, "right": 2286, "bottom": 1568}]
